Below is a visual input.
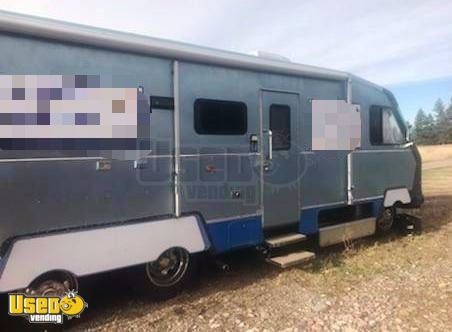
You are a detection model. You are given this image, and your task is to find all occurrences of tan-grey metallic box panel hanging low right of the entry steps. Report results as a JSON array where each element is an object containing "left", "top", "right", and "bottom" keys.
[{"left": 319, "top": 218, "right": 376, "bottom": 247}]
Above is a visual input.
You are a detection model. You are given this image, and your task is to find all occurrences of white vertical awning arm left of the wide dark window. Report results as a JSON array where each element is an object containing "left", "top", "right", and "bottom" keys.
[{"left": 173, "top": 61, "right": 181, "bottom": 217}]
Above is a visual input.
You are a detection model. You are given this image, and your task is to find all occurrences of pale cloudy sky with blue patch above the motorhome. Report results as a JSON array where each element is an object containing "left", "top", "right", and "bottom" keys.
[{"left": 0, "top": 0, "right": 452, "bottom": 122}]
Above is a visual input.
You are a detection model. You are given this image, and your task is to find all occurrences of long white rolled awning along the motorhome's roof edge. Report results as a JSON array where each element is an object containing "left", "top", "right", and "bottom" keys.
[{"left": 0, "top": 10, "right": 350, "bottom": 80}]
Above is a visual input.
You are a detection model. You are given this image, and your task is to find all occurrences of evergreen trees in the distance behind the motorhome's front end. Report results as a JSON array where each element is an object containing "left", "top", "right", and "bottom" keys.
[{"left": 412, "top": 99, "right": 452, "bottom": 144}]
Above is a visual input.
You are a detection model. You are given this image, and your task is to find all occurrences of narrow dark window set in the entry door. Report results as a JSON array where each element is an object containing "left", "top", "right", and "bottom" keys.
[{"left": 270, "top": 104, "right": 290, "bottom": 150}]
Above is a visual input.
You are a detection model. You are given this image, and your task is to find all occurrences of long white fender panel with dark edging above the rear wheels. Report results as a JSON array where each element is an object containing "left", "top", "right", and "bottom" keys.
[{"left": 0, "top": 215, "right": 210, "bottom": 292}]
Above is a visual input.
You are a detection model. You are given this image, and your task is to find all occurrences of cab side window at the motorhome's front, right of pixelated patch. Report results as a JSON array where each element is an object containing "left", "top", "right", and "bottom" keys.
[{"left": 369, "top": 106, "right": 405, "bottom": 145}]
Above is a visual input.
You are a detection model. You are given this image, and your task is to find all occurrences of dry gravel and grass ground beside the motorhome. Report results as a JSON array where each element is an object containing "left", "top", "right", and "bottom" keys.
[{"left": 0, "top": 147, "right": 452, "bottom": 331}]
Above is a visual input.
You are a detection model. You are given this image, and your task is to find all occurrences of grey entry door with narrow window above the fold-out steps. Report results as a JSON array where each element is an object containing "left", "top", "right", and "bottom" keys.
[{"left": 261, "top": 91, "right": 301, "bottom": 228}]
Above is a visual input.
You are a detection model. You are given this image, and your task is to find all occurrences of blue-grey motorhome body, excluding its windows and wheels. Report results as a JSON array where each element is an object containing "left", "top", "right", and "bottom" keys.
[{"left": 0, "top": 12, "right": 422, "bottom": 291}]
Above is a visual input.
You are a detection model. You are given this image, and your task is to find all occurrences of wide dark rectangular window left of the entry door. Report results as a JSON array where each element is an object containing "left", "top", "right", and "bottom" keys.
[{"left": 195, "top": 99, "right": 247, "bottom": 135}]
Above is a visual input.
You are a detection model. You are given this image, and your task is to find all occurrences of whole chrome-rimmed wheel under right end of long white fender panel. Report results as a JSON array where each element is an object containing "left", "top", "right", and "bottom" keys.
[{"left": 144, "top": 248, "right": 198, "bottom": 300}]
